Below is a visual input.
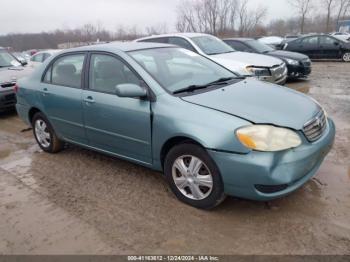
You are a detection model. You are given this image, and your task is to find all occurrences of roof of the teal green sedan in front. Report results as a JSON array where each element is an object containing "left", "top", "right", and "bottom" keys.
[{"left": 64, "top": 42, "right": 174, "bottom": 52}]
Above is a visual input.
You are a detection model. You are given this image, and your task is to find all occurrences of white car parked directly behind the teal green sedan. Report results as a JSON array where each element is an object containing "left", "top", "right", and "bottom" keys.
[{"left": 135, "top": 33, "right": 288, "bottom": 84}]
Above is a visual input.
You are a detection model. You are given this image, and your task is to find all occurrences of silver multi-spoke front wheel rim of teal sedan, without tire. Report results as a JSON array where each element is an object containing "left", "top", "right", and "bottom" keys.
[{"left": 172, "top": 155, "right": 214, "bottom": 200}]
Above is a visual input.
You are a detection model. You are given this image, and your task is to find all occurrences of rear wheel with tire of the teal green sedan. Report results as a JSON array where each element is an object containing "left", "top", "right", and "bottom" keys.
[{"left": 32, "top": 112, "right": 64, "bottom": 154}]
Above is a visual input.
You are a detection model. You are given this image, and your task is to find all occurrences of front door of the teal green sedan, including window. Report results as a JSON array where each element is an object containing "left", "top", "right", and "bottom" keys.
[{"left": 83, "top": 53, "right": 152, "bottom": 165}]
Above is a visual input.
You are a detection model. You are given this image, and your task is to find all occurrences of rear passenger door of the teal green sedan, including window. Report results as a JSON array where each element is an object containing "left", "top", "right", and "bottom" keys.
[{"left": 40, "top": 53, "right": 87, "bottom": 144}]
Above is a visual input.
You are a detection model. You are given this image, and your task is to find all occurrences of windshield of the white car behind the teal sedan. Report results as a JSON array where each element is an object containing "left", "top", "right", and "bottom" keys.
[{"left": 191, "top": 36, "right": 235, "bottom": 55}]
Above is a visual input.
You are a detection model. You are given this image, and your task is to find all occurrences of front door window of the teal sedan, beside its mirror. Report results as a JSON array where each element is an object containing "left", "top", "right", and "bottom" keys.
[{"left": 89, "top": 54, "right": 141, "bottom": 94}]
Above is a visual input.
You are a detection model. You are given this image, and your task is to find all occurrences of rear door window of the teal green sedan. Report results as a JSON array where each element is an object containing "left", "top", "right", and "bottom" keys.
[{"left": 50, "top": 54, "right": 85, "bottom": 88}]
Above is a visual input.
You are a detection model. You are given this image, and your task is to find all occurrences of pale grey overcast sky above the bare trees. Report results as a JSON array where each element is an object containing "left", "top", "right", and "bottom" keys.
[{"left": 0, "top": 0, "right": 318, "bottom": 35}]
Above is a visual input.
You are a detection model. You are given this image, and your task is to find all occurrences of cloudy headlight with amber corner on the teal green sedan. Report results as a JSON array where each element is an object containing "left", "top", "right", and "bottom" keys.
[{"left": 236, "top": 125, "right": 301, "bottom": 152}]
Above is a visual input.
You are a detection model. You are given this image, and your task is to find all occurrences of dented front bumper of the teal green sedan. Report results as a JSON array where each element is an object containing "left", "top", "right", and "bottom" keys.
[{"left": 209, "top": 119, "right": 335, "bottom": 201}]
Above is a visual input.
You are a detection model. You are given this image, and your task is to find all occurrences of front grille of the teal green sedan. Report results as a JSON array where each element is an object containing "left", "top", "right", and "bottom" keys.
[{"left": 303, "top": 109, "right": 327, "bottom": 142}]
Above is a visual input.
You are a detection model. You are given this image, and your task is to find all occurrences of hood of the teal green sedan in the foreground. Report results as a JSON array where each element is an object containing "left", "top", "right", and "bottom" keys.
[{"left": 182, "top": 79, "right": 320, "bottom": 130}]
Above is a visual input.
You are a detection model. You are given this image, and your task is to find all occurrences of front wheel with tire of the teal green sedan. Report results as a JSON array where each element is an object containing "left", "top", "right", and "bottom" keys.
[{"left": 164, "top": 143, "right": 225, "bottom": 209}]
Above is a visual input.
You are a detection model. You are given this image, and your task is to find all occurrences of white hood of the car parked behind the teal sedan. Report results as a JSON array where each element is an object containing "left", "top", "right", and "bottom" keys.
[{"left": 210, "top": 52, "right": 282, "bottom": 75}]
